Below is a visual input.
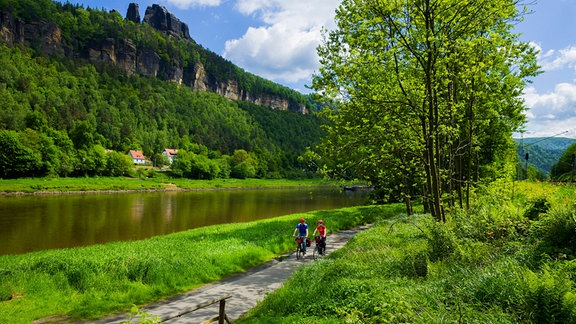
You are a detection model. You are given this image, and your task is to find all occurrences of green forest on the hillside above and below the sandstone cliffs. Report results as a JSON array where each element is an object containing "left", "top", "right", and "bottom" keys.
[{"left": 0, "top": 0, "right": 321, "bottom": 178}]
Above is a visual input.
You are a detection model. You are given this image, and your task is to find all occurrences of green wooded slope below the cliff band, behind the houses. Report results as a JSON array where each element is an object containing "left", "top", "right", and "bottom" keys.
[{"left": 0, "top": 41, "right": 320, "bottom": 178}]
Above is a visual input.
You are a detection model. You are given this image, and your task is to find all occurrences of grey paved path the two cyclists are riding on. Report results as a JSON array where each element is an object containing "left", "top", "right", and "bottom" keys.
[{"left": 96, "top": 225, "right": 369, "bottom": 324}]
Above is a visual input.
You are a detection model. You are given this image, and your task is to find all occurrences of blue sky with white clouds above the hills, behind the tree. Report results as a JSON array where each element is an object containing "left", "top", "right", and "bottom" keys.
[{"left": 69, "top": 0, "right": 576, "bottom": 138}]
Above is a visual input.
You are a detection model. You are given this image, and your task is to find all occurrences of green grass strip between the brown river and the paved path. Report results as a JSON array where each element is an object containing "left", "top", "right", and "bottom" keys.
[{"left": 0, "top": 206, "right": 388, "bottom": 323}]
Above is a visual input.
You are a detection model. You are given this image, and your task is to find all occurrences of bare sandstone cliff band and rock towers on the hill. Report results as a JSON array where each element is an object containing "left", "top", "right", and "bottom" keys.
[{"left": 0, "top": 3, "right": 308, "bottom": 114}]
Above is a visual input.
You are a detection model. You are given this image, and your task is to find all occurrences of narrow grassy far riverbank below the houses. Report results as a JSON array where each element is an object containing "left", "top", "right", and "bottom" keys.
[{"left": 0, "top": 175, "right": 360, "bottom": 196}]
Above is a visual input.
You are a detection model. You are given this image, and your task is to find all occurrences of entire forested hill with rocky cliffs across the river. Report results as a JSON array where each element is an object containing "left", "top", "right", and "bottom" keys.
[{"left": 0, "top": 0, "right": 323, "bottom": 178}]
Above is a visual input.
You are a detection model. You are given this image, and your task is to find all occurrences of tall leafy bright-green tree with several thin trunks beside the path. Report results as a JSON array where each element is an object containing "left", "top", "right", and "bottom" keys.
[{"left": 313, "top": 0, "right": 538, "bottom": 221}]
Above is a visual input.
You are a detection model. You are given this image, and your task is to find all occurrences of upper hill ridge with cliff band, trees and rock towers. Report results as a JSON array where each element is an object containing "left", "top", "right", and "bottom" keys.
[{"left": 0, "top": 0, "right": 313, "bottom": 113}]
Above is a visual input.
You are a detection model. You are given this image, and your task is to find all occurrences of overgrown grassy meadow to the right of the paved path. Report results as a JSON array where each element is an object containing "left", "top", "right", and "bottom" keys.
[{"left": 235, "top": 183, "right": 576, "bottom": 323}]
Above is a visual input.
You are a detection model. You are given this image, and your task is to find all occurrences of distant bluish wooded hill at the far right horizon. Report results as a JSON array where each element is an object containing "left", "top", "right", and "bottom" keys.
[{"left": 514, "top": 137, "right": 576, "bottom": 176}]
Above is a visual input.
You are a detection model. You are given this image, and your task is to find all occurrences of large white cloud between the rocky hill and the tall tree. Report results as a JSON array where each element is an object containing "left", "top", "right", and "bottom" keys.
[{"left": 224, "top": 0, "right": 339, "bottom": 83}]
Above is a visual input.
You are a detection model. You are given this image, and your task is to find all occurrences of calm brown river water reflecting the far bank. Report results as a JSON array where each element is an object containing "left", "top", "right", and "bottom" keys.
[{"left": 0, "top": 188, "right": 368, "bottom": 255}]
